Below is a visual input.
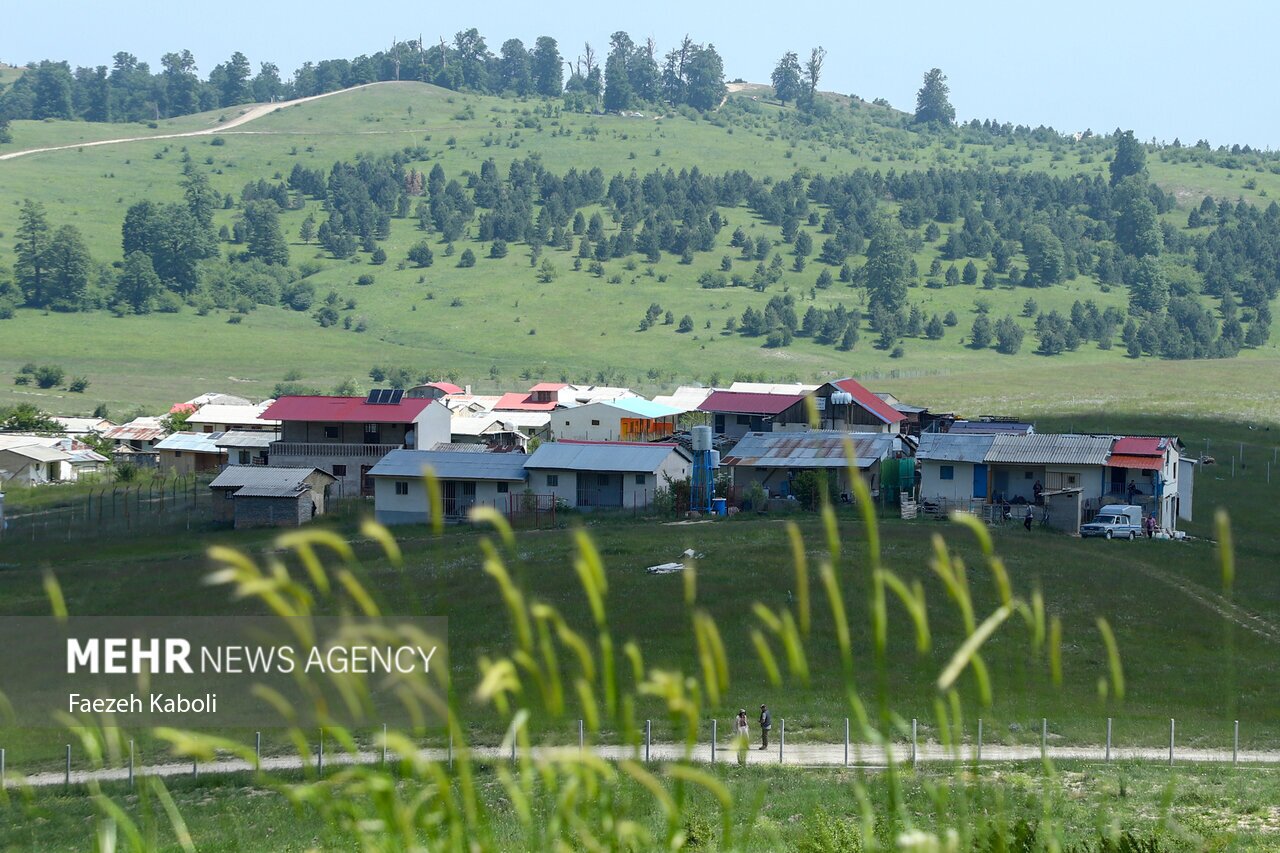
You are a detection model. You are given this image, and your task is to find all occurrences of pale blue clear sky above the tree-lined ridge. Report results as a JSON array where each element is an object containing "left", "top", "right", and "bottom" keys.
[{"left": 0, "top": 0, "right": 1280, "bottom": 149}]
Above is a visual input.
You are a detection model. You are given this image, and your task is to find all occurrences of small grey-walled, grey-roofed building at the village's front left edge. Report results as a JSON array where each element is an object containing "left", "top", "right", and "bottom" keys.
[{"left": 209, "top": 465, "right": 337, "bottom": 530}]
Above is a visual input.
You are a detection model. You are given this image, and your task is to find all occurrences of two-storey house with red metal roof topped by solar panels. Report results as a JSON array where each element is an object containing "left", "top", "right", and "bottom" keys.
[{"left": 262, "top": 389, "right": 451, "bottom": 497}]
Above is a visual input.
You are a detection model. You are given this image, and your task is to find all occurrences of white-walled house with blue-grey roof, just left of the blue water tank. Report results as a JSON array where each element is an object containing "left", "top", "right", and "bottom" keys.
[{"left": 525, "top": 441, "right": 691, "bottom": 510}]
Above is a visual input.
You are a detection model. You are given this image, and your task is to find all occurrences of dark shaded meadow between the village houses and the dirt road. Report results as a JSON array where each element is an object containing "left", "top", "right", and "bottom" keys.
[{"left": 0, "top": 418, "right": 1280, "bottom": 770}]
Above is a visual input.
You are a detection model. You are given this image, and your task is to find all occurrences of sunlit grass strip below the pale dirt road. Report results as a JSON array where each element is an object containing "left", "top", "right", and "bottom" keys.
[{"left": 0, "top": 763, "right": 1280, "bottom": 853}]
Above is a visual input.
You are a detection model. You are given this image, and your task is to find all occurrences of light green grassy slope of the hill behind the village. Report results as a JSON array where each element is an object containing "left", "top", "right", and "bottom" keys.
[{"left": 0, "top": 83, "right": 1280, "bottom": 421}]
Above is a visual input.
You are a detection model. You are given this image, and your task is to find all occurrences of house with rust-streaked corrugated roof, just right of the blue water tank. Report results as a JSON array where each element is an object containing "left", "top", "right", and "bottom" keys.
[{"left": 721, "top": 429, "right": 909, "bottom": 500}]
